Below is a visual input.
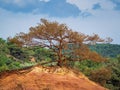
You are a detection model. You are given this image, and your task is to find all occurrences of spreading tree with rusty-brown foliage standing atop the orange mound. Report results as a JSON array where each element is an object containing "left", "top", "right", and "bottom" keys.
[{"left": 9, "top": 19, "right": 105, "bottom": 66}]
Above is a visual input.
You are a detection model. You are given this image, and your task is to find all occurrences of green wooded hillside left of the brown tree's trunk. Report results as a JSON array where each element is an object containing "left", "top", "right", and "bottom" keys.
[{"left": 0, "top": 38, "right": 54, "bottom": 72}]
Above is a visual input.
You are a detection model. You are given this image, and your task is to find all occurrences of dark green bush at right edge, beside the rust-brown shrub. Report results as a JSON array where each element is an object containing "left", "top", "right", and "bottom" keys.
[{"left": 106, "top": 56, "right": 120, "bottom": 90}]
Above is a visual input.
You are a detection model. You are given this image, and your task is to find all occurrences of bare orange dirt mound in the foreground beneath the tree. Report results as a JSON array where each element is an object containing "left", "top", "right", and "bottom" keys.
[{"left": 0, "top": 66, "right": 106, "bottom": 90}]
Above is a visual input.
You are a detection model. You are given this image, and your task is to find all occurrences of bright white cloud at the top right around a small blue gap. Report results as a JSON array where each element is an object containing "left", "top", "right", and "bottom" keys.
[{"left": 66, "top": 0, "right": 116, "bottom": 15}]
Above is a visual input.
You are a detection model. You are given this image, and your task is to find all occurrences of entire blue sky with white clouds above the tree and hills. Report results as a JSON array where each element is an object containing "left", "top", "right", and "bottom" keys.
[{"left": 0, "top": 0, "right": 120, "bottom": 44}]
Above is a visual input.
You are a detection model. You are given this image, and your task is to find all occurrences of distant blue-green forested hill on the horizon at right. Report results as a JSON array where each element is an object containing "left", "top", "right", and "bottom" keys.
[{"left": 89, "top": 44, "right": 120, "bottom": 57}]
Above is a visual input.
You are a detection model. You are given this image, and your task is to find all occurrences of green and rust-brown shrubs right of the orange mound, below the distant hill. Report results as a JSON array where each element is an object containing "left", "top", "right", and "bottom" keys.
[{"left": 74, "top": 58, "right": 120, "bottom": 90}]
